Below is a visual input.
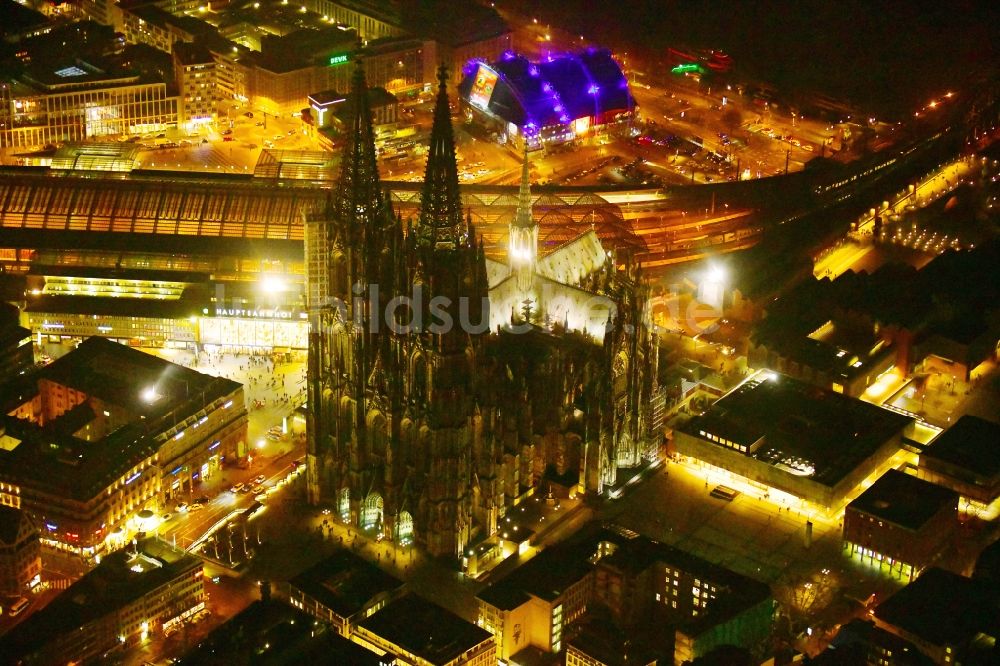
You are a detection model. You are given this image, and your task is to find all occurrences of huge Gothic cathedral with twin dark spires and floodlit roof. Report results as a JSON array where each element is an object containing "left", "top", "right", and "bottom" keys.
[{"left": 306, "top": 57, "right": 663, "bottom": 558}]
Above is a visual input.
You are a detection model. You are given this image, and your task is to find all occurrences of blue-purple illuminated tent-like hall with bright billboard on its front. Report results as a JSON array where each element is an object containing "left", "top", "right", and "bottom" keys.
[{"left": 459, "top": 49, "right": 635, "bottom": 134}]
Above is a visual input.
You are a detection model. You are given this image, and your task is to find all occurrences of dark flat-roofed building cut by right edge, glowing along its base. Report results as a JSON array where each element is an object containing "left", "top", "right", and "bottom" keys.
[{"left": 915, "top": 414, "right": 1000, "bottom": 520}]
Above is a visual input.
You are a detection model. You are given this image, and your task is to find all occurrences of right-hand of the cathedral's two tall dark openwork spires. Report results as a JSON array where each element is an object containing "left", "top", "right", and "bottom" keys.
[{"left": 419, "top": 65, "right": 465, "bottom": 246}]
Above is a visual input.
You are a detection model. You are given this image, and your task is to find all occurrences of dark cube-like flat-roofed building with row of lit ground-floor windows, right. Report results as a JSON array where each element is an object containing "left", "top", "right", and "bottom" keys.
[{"left": 843, "top": 469, "right": 958, "bottom": 580}]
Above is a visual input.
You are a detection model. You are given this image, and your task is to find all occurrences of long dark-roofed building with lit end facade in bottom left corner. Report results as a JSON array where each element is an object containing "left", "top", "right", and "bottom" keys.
[{"left": 0, "top": 539, "right": 205, "bottom": 664}]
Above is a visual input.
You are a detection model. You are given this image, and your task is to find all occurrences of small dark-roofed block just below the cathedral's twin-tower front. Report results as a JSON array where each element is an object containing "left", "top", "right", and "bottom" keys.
[{"left": 286, "top": 550, "right": 403, "bottom": 638}]
